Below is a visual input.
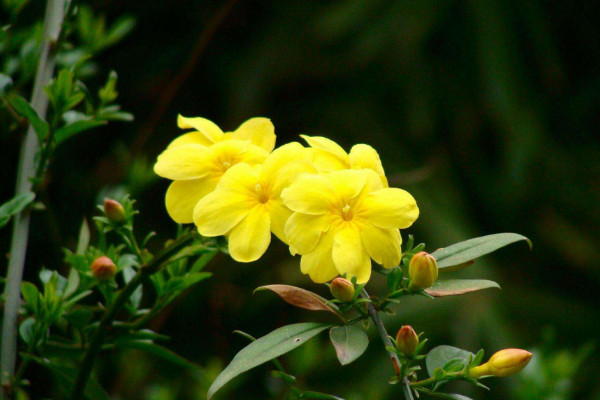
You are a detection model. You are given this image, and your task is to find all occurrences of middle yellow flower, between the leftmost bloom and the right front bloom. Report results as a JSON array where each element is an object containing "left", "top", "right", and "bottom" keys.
[{"left": 194, "top": 142, "right": 316, "bottom": 262}]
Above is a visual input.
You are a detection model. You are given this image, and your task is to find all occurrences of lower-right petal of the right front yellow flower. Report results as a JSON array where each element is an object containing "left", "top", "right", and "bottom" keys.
[{"left": 359, "top": 223, "right": 402, "bottom": 268}]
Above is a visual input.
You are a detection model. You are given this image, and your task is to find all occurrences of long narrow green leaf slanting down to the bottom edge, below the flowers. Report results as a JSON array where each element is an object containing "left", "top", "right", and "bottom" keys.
[{"left": 207, "top": 322, "right": 331, "bottom": 400}]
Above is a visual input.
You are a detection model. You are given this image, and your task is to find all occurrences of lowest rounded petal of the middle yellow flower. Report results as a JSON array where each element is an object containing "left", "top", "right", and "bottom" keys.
[{"left": 229, "top": 204, "right": 271, "bottom": 262}]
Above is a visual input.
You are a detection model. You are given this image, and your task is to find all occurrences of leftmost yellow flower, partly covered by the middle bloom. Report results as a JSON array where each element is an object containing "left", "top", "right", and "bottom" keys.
[{"left": 154, "top": 115, "right": 275, "bottom": 224}]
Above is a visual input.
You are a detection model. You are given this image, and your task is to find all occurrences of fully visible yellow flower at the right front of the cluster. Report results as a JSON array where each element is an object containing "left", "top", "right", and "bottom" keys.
[{"left": 281, "top": 169, "right": 419, "bottom": 283}]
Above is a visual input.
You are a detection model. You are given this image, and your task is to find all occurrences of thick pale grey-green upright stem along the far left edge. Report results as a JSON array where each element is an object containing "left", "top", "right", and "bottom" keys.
[{"left": 0, "top": 0, "right": 65, "bottom": 398}]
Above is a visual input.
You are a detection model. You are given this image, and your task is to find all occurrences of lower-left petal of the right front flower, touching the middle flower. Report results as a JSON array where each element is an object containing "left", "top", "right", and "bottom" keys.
[{"left": 285, "top": 213, "right": 332, "bottom": 254}]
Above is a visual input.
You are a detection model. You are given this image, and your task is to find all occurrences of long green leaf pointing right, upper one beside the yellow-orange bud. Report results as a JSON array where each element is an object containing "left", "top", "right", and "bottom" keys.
[{"left": 431, "top": 233, "right": 531, "bottom": 268}]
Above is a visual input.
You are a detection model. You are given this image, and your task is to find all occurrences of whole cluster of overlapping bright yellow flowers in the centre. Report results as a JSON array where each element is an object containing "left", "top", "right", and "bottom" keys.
[{"left": 154, "top": 116, "right": 419, "bottom": 283}]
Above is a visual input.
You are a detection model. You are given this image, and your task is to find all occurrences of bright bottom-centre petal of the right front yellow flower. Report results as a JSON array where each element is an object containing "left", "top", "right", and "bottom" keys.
[{"left": 332, "top": 224, "right": 371, "bottom": 283}]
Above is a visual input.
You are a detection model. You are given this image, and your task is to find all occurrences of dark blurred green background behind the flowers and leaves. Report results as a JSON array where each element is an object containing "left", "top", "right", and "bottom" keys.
[{"left": 0, "top": 0, "right": 600, "bottom": 400}]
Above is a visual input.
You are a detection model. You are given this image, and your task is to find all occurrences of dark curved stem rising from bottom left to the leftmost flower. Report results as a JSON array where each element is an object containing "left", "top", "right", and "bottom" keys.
[{"left": 71, "top": 234, "right": 193, "bottom": 400}]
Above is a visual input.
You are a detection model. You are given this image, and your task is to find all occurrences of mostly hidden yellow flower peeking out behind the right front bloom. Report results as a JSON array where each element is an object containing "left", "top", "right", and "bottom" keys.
[{"left": 300, "top": 135, "right": 388, "bottom": 187}]
